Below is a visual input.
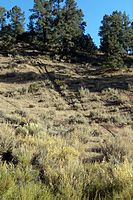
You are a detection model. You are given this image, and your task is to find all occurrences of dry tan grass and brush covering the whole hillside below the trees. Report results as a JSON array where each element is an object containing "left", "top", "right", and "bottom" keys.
[{"left": 0, "top": 56, "right": 133, "bottom": 200}]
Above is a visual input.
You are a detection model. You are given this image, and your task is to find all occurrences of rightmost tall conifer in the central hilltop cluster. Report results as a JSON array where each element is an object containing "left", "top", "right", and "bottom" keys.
[{"left": 60, "top": 0, "right": 85, "bottom": 54}]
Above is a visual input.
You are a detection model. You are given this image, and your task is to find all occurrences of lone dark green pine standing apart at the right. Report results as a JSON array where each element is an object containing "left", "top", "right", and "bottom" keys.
[{"left": 99, "top": 11, "right": 130, "bottom": 67}]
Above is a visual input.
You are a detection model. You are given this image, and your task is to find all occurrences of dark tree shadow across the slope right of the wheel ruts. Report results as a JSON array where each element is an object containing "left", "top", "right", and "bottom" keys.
[{"left": 46, "top": 74, "right": 133, "bottom": 92}]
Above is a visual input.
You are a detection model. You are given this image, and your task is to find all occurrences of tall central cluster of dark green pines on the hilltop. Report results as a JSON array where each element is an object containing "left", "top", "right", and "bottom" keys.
[{"left": 28, "top": 0, "right": 85, "bottom": 55}]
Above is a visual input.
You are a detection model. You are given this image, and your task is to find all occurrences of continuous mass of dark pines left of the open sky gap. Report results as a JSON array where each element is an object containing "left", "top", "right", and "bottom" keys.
[{"left": 0, "top": 0, "right": 96, "bottom": 58}]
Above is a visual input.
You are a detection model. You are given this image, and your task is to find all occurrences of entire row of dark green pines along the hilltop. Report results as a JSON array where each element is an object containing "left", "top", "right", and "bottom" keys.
[{"left": 0, "top": 0, "right": 133, "bottom": 66}]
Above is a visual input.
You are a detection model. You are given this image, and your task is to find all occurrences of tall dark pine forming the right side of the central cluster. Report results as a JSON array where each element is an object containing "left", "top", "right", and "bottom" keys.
[{"left": 54, "top": 0, "right": 85, "bottom": 55}]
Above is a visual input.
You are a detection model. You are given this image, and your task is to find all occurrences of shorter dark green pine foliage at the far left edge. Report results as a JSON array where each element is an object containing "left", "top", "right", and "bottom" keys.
[{"left": 0, "top": 6, "right": 25, "bottom": 52}]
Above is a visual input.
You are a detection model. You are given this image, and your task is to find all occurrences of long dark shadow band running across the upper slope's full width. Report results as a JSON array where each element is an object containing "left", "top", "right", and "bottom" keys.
[{"left": 0, "top": 64, "right": 133, "bottom": 92}]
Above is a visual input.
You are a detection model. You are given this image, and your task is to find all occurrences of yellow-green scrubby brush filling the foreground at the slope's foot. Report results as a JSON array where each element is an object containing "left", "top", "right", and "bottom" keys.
[{"left": 0, "top": 120, "right": 133, "bottom": 200}]
